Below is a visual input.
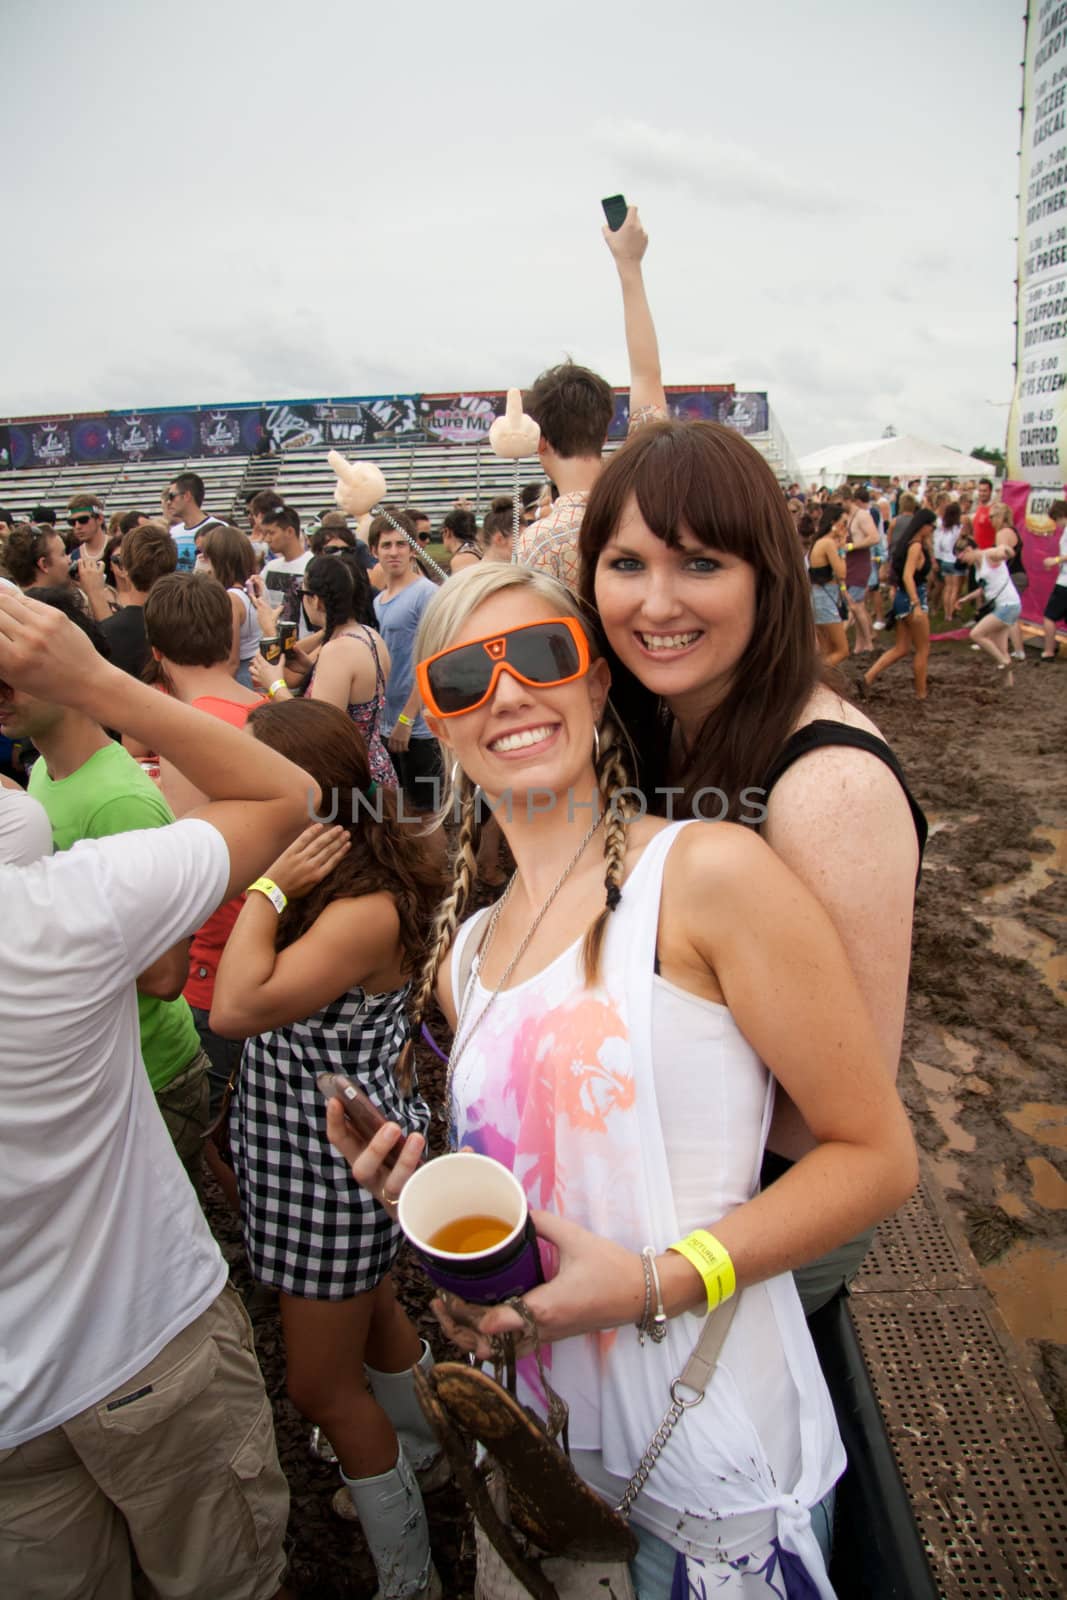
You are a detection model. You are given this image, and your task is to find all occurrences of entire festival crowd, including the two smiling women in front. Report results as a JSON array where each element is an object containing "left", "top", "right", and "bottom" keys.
[{"left": 0, "top": 210, "right": 1067, "bottom": 1600}]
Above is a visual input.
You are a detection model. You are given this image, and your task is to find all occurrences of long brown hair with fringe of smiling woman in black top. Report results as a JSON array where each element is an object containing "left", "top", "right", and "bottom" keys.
[{"left": 581, "top": 421, "right": 821, "bottom": 819}]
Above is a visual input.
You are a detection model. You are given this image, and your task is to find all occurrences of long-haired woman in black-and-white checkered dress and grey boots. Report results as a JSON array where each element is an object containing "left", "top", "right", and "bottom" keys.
[{"left": 211, "top": 699, "right": 442, "bottom": 1595}]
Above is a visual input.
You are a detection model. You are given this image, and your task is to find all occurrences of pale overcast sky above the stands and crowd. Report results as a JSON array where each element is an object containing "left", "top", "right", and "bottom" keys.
[{"left": 0, "top": 0, "right": 1024, "bottom": 453}]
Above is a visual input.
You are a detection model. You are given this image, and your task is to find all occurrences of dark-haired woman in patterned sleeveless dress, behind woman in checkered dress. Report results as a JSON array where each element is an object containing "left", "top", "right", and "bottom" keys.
[{"left": 253, "top": 555, "right": 397, "bottom": 789}]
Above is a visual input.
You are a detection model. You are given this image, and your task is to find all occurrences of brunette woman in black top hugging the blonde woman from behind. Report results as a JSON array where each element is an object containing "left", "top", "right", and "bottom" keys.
[{"left": 581, "top": 422, "right": 926, "bottom": 1312}]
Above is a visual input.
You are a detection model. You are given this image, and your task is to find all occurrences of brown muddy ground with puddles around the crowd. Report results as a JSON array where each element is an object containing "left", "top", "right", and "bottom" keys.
[{"left": 204, "top": 630, "right": 1067, "bottom": 1600}]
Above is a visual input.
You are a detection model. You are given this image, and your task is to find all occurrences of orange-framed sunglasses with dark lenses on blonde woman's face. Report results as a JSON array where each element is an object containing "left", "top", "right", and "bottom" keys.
[{"left": 416, "top": 616, "right": 589, "bottom": 717}]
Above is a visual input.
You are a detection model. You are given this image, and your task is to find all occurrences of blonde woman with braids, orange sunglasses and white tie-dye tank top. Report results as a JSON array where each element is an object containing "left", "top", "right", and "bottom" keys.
[{"left": 328, "top": 563, "right": 917, "bottom": 1600}]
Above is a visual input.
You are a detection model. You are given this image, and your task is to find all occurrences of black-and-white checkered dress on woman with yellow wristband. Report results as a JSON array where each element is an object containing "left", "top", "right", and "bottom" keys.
[{"left": 230, "top": 987, "right": 430, "bottom": 1299}]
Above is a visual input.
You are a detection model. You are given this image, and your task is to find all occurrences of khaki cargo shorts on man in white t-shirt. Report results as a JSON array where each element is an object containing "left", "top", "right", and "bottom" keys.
[{"left": 0, "top": 1288, "right": 290, "bottom": 1600}]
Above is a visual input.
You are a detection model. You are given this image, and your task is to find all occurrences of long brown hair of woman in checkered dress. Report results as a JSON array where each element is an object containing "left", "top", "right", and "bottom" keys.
[{"left": 248, "top": 699, "right": 443, "bottom": 973}]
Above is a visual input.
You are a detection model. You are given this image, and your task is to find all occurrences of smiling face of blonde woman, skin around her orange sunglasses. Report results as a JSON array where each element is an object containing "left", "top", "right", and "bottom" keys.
[{"left": 427, "top": 587, "right": 609, "bottom": 798}]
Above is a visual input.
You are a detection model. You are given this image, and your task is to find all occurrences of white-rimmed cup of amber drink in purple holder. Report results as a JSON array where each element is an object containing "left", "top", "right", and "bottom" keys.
[{"left": 398, "top": 1152, "right": 544, "bottom": 1306}]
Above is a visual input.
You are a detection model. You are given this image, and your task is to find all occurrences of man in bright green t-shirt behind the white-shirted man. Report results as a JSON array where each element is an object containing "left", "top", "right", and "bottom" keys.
[{"left": 0, "top": 589, "right": 208, "bottom": 1184}]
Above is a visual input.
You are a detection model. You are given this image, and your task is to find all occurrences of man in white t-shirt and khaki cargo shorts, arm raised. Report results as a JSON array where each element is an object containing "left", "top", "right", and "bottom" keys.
[{"left": 0, "top": 592, "right": 314, "bottom": 1600}]
